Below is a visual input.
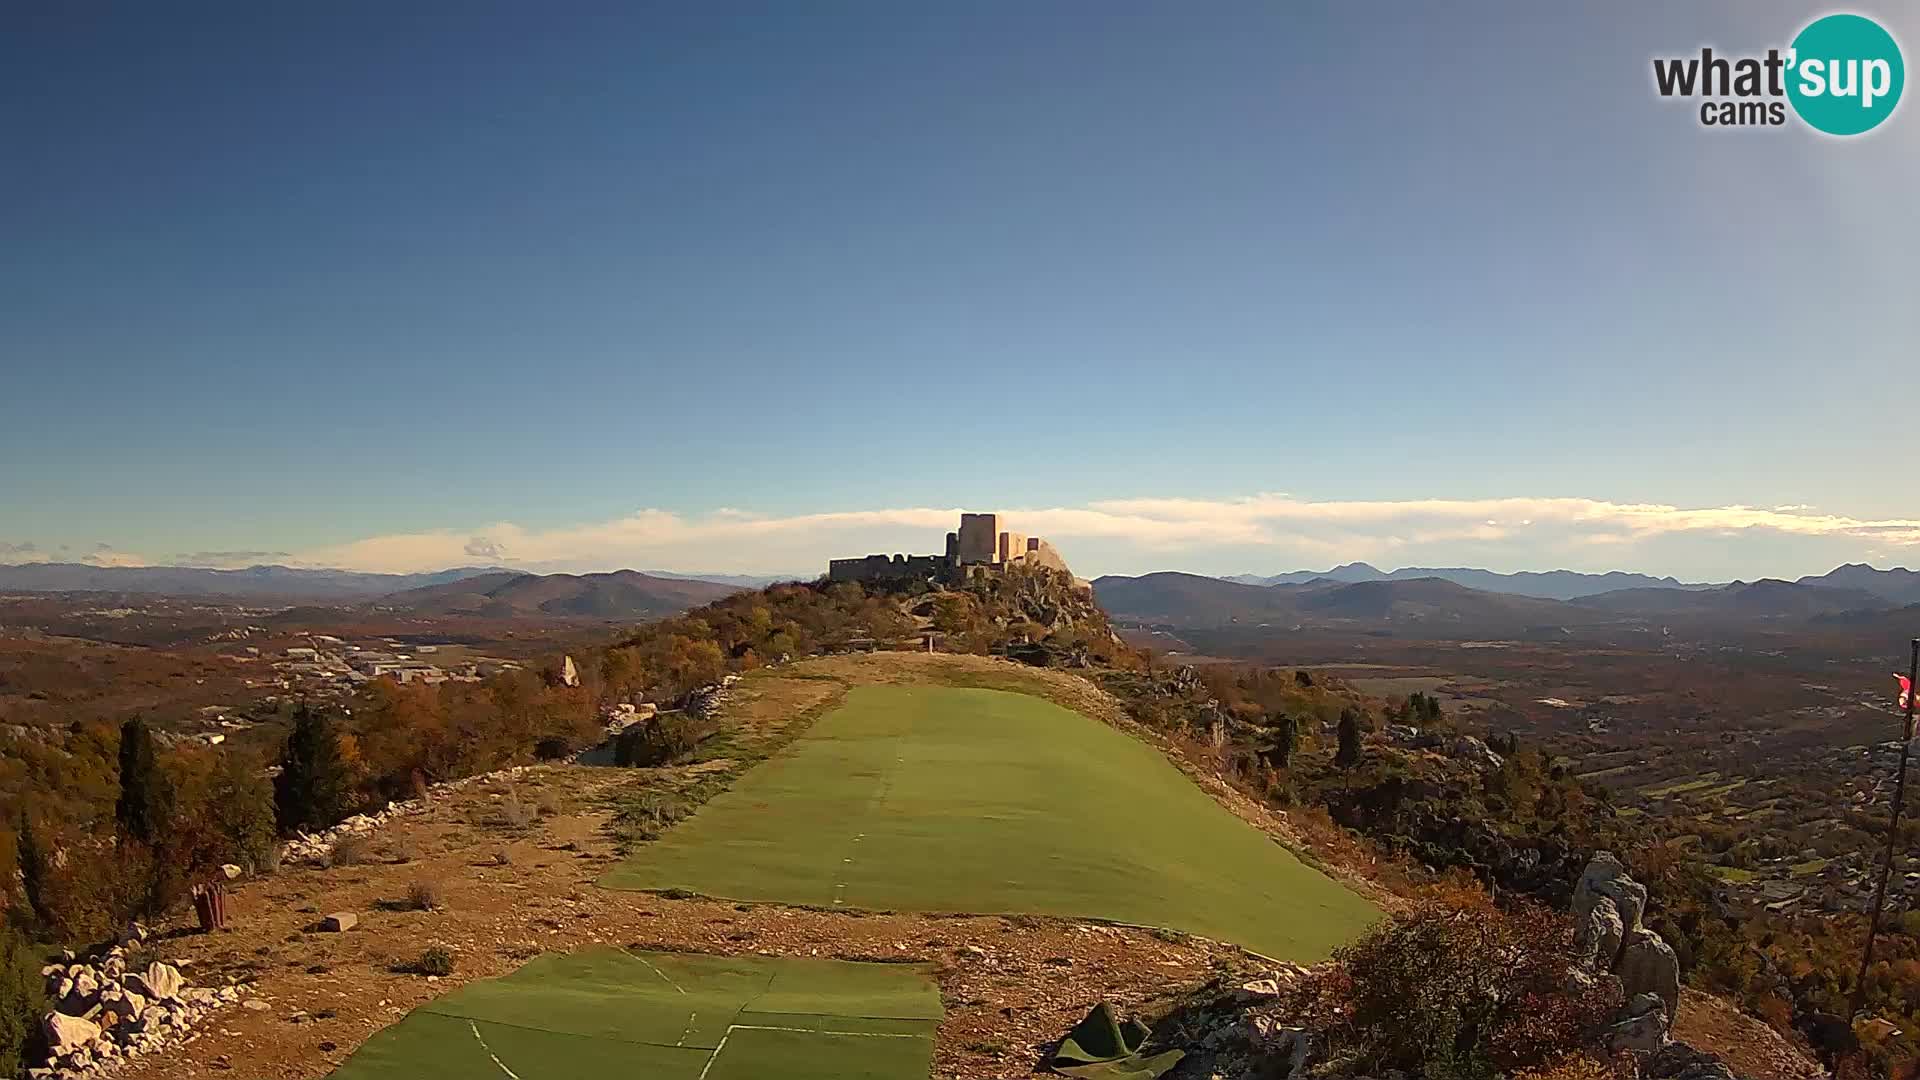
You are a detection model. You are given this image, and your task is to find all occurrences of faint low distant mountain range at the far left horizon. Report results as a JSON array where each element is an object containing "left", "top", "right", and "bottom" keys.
[{"left": 0, "top": 563, "right": 499, "bottom": 601}]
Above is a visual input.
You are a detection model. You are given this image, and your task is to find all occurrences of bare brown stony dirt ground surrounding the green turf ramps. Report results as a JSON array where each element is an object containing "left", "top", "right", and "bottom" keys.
[{"left": 108, "top": 653, "right": 1818, "bottom": 1080}]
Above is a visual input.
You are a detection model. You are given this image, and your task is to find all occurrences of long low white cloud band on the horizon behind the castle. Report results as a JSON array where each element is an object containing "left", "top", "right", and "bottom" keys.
[{"left": 266, "top": 494, "right": 1920, "bottom": 573}]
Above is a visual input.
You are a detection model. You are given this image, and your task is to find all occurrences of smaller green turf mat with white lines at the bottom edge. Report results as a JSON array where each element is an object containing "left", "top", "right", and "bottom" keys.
[{"left": 334, "top": 949, "right": 941, "bottom": 1080}]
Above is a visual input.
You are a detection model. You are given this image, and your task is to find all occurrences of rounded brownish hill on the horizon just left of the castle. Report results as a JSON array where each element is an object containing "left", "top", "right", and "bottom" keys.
[{"left": 378, "top": 571, "right": 739, "bottom": 619}]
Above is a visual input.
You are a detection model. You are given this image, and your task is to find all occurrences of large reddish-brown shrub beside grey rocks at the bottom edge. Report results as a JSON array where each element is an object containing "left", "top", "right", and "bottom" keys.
[{"left": 1296, "top": 888, "right": 1620, "bottom": 1080}]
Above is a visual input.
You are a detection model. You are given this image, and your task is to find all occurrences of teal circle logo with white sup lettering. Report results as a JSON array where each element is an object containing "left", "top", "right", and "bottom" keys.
[{"left": 1788, "top": 15, "right": 1907, "bottom": 135}]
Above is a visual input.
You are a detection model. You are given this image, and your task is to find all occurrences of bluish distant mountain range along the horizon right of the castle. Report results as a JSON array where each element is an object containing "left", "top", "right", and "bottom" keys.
[{"left": 1092, "top": 563, "right": 1920, "bottom": 634}]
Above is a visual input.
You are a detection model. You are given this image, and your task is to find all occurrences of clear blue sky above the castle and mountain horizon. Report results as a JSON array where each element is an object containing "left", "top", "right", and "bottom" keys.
[{"left": 0, "top": 2, "right": 1920, "bottom": 578}]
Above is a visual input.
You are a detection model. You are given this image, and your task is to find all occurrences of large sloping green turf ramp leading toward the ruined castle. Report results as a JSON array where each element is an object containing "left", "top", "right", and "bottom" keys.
[{"left": 601, "top": 686, "right": 1379, "bottom": 963}]
